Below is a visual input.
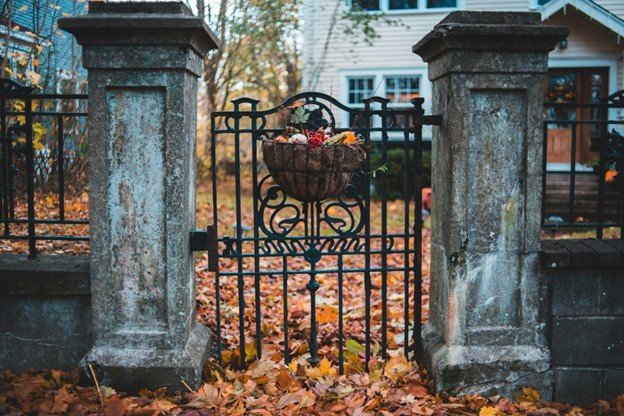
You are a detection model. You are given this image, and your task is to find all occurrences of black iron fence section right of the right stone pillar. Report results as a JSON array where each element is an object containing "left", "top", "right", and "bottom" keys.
[{"left": 542, "top": 90, "right": 624, "bottom": 239}]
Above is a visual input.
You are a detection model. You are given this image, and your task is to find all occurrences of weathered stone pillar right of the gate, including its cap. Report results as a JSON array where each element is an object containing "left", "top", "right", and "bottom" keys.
[{"left": 413, "top": 11, "right": 569, "bottom": 397}]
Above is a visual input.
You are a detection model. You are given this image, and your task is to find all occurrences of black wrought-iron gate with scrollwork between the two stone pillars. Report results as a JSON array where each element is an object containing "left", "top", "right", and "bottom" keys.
[{"left": 204, "top": 92, "right": 440, "bottom": 372}]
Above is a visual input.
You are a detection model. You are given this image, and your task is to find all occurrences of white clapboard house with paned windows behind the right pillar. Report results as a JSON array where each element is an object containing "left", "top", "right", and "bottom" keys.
[{"left": 303, "top": 0, "right": 624, "bottom": 169}]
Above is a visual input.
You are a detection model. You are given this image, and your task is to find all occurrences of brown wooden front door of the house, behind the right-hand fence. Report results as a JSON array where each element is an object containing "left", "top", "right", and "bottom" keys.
[{"left": 545, "top": 68, "right": 609, "bottom": 168}]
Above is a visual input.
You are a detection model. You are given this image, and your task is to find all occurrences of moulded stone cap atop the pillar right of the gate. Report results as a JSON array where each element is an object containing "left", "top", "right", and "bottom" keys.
[{"left": 412, "top": 11, "right": 570, "bottom": 62}]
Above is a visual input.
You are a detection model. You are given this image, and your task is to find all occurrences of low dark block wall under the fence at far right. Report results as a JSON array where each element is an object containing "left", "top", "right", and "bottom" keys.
[{"left": 542, "top": 240, "right": 624, "bottom": 405}]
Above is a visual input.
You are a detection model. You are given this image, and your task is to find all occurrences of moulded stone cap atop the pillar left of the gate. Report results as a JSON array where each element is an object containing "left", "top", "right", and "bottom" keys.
[{"left": 58, "top": 1, "right": 219, "bottom": 57}]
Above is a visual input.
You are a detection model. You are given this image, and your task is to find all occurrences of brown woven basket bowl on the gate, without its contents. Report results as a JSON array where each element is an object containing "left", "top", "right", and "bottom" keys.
[{"left": 262, "top": 140, "right": 366, "bottom": 202}]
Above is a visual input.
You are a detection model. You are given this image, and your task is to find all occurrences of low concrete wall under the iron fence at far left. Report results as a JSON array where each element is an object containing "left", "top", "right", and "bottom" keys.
[{"left": 0, "top": 255, "right": 91, "bottom": 371}]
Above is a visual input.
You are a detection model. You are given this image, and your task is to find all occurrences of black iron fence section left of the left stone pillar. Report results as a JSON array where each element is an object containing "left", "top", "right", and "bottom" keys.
[{"left": 0, "top": 79, "right": 88, "bottom": 258}]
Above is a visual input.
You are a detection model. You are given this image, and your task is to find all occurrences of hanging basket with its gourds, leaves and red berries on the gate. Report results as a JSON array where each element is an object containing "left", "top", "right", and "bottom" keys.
[{"left": 262, "top": 105, "right": 366, "bottom": 202}]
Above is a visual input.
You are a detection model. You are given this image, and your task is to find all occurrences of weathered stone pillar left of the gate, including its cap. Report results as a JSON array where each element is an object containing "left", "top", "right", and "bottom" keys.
[{"left": 59, "top": 2, "right": 217, "bottom": 391}]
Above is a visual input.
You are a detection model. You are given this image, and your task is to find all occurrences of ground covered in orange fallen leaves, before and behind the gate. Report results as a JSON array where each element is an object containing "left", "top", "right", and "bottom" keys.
[{"left": 0, "top": 188, "right": 624, "bottom": 416}]
